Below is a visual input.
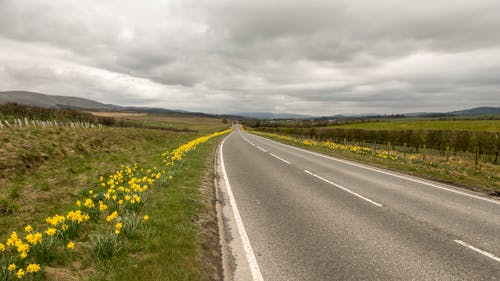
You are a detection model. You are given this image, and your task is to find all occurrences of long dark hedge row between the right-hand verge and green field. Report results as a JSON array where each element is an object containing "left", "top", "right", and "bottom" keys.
[{"left": 257, "top": 127, "right": 500, "bottom": 164}]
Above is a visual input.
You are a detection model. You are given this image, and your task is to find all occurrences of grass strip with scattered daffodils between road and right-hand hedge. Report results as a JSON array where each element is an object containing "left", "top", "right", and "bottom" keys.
[{"left": 248, "top": 131, "right": 500, "bottom": 195}]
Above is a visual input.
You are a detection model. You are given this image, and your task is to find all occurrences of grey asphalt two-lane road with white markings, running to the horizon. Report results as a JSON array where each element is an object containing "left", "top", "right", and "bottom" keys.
[{"left": 220, "top": 128, "right": 500, "bottom": 280}]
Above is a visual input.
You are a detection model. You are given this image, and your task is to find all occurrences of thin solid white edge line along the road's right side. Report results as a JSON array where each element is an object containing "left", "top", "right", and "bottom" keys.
[{"left": 250, "top": 132, "right": 500, "bottom": 205}]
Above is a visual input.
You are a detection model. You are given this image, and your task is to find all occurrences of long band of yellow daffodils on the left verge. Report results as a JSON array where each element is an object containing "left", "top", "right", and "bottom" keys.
[{"left": 0, "top": 130, "right": 230, "bottom": 280}]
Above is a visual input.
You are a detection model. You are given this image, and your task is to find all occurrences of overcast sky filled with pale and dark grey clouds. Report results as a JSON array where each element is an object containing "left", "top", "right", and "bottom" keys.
[{"left": 0, "top": 0, "right": 500, "bottom": 115}]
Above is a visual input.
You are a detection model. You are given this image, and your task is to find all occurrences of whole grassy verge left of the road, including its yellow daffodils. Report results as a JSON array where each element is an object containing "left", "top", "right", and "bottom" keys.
[{"left": 0, "top": 104, "right": 228, "bottom": 280}]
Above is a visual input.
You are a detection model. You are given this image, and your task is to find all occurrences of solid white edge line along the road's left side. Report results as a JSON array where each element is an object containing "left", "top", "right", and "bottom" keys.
[{"left": 220, "top": 137, "right": 264, "bottom": 281}]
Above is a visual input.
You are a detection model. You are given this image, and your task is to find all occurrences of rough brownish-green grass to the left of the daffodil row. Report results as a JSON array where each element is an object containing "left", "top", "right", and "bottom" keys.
[{"left": 0, "top": 128, "right": 192, "bottom": 238}]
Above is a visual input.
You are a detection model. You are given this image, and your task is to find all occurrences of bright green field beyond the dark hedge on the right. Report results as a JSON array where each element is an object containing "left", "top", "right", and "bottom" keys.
[{"left": 332, "top": 119, "right": 500, "bottom": 132}]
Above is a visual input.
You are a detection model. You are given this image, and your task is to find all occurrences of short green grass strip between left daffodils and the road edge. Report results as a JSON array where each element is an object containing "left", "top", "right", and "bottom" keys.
[{"left": 90, "top": 137, "right": 221, "bottom": 281}]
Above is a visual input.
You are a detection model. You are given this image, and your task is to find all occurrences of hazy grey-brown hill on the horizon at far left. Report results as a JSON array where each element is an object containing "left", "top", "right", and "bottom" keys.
[{"left": 0, "top": 91, "right": 122, "bottom": 110}]
